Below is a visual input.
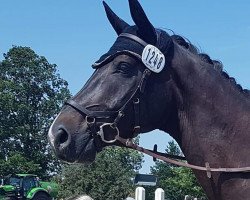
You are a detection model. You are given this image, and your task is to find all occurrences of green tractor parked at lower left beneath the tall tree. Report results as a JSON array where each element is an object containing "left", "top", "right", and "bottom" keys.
[{"left": 0, "top": 174, "right": 58, "bottom": 200}]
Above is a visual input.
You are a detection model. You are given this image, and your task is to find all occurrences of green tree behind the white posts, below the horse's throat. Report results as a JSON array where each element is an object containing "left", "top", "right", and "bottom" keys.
[{"left": 150, "top": 141, "right": 205, "bottom": 200}]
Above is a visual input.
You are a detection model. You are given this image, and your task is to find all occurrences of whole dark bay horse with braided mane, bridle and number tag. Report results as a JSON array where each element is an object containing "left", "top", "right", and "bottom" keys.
[{"left": 49, "top": 0, "right": 250, "bottom": 200}]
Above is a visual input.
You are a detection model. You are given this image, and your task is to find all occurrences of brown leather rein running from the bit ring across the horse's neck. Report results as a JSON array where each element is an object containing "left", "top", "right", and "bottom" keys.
[{"left": 116, "top": 136, "right": 250, "bottom": 178}]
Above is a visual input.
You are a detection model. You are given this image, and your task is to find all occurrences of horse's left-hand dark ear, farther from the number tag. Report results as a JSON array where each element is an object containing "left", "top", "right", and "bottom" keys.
[{"left": 103, "top": 1, "right": 129, "bottom": 35}]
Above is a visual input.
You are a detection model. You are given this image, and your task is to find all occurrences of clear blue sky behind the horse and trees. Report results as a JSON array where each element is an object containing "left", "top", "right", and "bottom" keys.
[{"left": 0, "top": 0, "right": 250, "bottom": 173}]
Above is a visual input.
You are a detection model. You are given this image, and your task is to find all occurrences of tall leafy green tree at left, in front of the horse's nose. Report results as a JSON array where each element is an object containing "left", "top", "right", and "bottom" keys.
[{"left": 0, "top": 46, "right": 70, "bottom": 177}]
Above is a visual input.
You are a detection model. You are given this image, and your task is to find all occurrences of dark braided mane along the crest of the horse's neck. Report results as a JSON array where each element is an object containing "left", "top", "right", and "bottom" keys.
[{"left": 171, "top": 34, "right": 250, "bottom": 95}]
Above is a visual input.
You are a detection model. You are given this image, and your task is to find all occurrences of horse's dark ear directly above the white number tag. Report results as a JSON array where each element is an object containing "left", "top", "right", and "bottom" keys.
[{"left": 129, "top": 0, "right": 157, "bottom": 45}]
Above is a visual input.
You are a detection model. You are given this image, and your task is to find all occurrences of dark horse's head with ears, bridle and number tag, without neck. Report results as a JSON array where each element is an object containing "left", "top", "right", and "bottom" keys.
[{"left": 49, "top": 0, "right": 174, "bottom": 162}]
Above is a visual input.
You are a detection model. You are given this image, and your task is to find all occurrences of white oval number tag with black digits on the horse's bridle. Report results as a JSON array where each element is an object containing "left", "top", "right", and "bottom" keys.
[{"left": 142, "top": 44, "right": 165, "bottom": 73}]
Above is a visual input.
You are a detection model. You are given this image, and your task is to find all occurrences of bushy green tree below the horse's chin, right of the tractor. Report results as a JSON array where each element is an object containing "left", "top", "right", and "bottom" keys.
[{"left": 58, "top": 147, "right": 142, "bottom": 200}]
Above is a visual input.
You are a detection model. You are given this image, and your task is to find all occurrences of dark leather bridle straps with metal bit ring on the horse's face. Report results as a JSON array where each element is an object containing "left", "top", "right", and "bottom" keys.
[{"left": 65, "top": 33, "right": 151, "bottom": 144}]
